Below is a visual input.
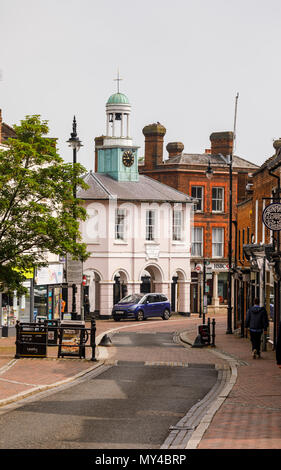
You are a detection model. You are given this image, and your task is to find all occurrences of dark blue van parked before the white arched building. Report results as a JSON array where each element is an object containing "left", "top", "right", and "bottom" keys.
[{"left": 112, "top": 293, "right": 171, "bottom": 321}]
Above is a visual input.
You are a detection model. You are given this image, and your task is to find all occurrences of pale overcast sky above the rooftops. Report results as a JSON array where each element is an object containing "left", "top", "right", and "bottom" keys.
[{"left": 0, "top": 0, "right": 281, "bottom": 170}]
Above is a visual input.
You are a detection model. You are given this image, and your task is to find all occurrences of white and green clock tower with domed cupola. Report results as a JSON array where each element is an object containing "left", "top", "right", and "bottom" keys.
[{"left": 96, "top": 74, "right": 139, "bottom": 181}]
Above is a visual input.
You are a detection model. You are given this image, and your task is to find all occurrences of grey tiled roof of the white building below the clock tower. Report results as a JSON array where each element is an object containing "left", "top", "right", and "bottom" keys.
[{"left": 77, "top": 172, "right": 193, "bottom": 203}]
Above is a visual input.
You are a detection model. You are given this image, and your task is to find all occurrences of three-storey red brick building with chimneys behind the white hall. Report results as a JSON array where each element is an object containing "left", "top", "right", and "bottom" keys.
[{"left": 140, "top": 123, "right": 258, "bottom": 313}]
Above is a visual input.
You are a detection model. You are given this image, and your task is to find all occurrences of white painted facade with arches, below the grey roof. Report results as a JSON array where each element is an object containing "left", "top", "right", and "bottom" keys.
[{"left": 80, "top": 199, "right": 192, "bottom": 317}]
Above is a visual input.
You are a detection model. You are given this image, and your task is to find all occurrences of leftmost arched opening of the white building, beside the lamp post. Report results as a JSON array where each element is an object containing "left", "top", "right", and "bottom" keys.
[{"left": 82, "top": 270, "right": 101, "bottom": 321}]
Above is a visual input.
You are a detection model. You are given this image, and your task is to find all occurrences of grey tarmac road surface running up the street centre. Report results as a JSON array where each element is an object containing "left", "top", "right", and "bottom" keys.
[{"left": 0, "top": 330, "right": 218, "bottom": 449}]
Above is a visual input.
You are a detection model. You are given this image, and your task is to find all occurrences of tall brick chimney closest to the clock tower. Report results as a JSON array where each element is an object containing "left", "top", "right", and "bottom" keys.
[{"left": 142, "top": 122, "right": 166, "bottom": 169}]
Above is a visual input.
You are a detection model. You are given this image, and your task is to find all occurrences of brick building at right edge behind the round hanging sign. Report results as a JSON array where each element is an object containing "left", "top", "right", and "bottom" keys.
[{"left": 236, "top": 139, "right": 281, "bottom": 344}]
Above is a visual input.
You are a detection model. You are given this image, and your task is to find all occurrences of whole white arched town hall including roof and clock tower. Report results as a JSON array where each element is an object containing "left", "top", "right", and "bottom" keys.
[{"left": 77, "top": 86, "right": 193, "bottom": 318}]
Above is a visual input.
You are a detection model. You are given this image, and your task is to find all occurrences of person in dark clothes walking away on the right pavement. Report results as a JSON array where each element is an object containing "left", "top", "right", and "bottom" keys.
[{"left": 246, "top": 298, "right": 269, "bottom": 359}]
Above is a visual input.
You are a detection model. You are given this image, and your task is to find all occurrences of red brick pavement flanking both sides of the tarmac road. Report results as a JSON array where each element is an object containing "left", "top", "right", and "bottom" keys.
[{"left": 0, "top": 315, "right": 281, "bottom": 450}]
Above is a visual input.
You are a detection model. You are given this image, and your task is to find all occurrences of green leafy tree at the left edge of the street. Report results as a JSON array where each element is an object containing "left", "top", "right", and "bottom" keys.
[{"left": 0, "top": 115, "right": 88, "bottom": 293}]
